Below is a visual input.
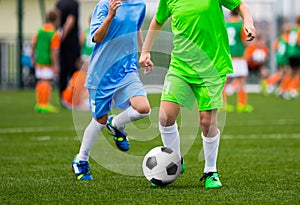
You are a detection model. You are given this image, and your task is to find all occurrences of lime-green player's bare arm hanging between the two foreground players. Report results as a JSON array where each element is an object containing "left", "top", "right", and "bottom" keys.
[{"left": 139, "top": 17, "right": 163, "bottom": 74}]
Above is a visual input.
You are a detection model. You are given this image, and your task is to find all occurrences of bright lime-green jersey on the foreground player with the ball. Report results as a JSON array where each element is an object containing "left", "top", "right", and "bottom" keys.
[{"left": 156, "top": 0, "right": 241, "bottom": 81}]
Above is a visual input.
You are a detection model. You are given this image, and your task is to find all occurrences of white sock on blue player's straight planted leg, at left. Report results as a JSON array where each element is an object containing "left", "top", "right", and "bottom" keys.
[{"left": 77, "top": 119, "right": 106, "bottom": 161}]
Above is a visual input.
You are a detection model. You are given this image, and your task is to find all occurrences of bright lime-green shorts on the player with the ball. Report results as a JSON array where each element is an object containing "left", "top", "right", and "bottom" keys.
[{"left": 161, "top": 72, "right": 226, "bottom": 111}]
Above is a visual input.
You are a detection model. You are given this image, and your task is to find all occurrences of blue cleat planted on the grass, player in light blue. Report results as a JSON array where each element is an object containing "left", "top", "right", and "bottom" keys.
[{"left": 72, "top": 154, "right": 93, "bottom": 180}]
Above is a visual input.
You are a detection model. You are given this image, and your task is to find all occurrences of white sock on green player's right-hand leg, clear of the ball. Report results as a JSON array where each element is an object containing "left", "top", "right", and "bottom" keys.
[{"left": 201, "top": 130, "right": 220, "bottom": 173}]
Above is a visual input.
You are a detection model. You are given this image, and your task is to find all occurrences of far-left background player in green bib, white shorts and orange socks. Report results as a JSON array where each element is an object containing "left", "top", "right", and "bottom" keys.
[{"left": 31, "top": 9, "right": 60, "bottom": 112}]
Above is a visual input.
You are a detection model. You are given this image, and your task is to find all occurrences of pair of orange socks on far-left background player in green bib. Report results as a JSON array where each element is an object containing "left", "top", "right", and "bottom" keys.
[{"left": 35, "top": 81, "right": 52, "bottom": 106}]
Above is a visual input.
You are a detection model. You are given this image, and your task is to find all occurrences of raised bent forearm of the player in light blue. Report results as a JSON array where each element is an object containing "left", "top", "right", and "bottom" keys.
[{"left": 93, "top": 0, "right": 122, "bottom": 43}]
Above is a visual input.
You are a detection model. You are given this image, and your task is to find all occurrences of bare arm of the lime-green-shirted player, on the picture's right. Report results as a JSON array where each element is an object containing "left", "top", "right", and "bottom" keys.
[{"left": 235, "top": 2, "right": 256, "bottom": 41}]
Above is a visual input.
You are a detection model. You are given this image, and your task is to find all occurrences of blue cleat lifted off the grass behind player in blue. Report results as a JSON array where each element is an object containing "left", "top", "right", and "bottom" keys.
[{"left": 106, "top": 115, "right": 130, "bottom": 151}]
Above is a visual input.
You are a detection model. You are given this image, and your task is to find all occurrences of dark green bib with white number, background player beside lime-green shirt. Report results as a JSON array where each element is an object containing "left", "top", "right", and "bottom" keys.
[{"left": 226, "top": 21, "right": 245, "bottom": 57}]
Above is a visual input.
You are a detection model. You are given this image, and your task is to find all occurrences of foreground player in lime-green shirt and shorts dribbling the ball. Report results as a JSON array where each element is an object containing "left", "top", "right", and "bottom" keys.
[{"left": 139, "top": 0, "right": 255, "bottom": 188}]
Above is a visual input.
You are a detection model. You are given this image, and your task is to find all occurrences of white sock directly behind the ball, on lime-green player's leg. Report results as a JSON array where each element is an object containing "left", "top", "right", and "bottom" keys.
[{"left": 159, "top": 122, "right": 181, "bottom": 157}]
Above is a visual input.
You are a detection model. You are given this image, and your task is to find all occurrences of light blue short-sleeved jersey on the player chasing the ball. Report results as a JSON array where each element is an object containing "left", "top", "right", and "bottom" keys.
[{"left": 85, "top": 0, "right": 146, "bottom": 89}]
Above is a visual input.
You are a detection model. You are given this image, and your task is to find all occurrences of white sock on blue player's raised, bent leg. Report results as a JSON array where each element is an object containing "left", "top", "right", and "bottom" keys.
[{"left": 112, "top": 106, "right": 150, "bottom": 128}]
